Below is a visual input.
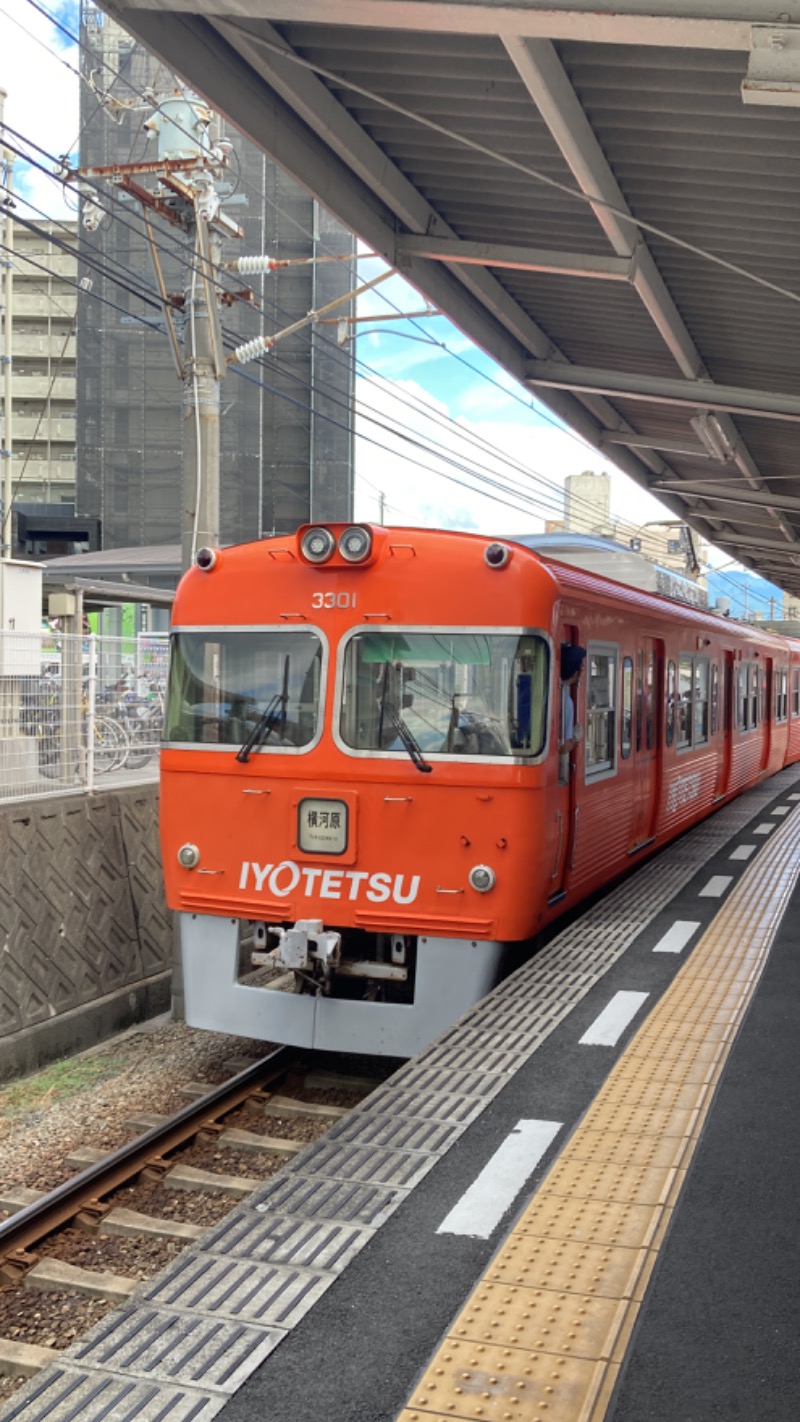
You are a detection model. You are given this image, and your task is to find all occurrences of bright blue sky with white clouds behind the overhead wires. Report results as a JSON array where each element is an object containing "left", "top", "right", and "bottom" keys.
[{"left": 0, "top": 0, "right": 784, "bottom": 619}]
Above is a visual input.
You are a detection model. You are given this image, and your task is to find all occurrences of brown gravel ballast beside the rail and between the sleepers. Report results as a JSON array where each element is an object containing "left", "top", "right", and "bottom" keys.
[{"left": 0, "top": 1018, "right": 381, "bottom": 1402}]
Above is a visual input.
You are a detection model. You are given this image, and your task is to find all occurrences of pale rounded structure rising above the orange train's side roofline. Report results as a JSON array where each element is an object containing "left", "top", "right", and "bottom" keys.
[{"left": 504, "top": 533, "right": 708, "bottom": 610}]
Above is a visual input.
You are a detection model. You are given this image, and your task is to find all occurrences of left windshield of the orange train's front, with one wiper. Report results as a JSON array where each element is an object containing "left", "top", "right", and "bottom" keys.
[{"left": 163, "top": 629, "right": 323, "bottom": 754}]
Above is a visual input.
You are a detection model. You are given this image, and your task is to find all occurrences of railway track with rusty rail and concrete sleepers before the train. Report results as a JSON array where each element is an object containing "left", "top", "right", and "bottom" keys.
[{"left": 0, "top": 1047, "right": 379, "bottom": 1396}]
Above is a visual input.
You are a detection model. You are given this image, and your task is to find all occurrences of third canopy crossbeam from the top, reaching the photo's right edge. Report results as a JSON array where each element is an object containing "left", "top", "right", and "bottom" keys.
[{"left": 524, "top": 360, "right": 800, "bottom": 421}]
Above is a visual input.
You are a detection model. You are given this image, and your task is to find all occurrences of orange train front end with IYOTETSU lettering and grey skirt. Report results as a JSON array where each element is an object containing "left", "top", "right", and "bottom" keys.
[{"left": 161, "top": 525, "right": 554, "bottom": 1057}]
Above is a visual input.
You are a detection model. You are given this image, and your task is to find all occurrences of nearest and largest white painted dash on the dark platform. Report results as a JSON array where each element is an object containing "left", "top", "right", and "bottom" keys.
[{"left": 436, "top": 1121, "right": 563, "bottom": 1240}]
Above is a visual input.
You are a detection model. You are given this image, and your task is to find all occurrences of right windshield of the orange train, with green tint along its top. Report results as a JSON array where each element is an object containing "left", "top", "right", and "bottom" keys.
[{"left": 340, "top": 631, "right": 550, "bottom": 758}]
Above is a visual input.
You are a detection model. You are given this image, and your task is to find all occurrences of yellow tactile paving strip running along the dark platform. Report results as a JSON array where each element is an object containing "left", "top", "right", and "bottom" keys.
[{"left": 396, "top": 815, "right": 800, "bottom": 1422}]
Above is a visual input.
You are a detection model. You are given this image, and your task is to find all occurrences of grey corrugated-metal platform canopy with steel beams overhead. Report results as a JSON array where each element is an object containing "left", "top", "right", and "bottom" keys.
[{"left": 104, "top": 0, "right": 800, "bottom": 593}]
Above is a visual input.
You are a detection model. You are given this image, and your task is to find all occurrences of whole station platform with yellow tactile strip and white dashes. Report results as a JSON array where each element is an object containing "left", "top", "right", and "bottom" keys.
[{"left": 6, "top": 766, "right": 800, "bottom": 1422}]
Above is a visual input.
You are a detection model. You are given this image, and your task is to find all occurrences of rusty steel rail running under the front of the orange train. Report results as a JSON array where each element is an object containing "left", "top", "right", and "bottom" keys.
[{"left": 0, "top": 1047, "right": 297, "bottom": 1277}]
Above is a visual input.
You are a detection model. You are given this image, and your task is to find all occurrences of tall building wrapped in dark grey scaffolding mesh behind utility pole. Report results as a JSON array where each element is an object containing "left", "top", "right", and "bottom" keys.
[{"left": 77, "top": 0, "right": 355, "bottom": 549}]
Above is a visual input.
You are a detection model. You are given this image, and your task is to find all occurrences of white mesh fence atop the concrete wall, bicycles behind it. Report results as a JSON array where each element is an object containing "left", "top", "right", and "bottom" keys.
[{"left": 0, "top": 631, "right": 169, "bottom": 801}]
